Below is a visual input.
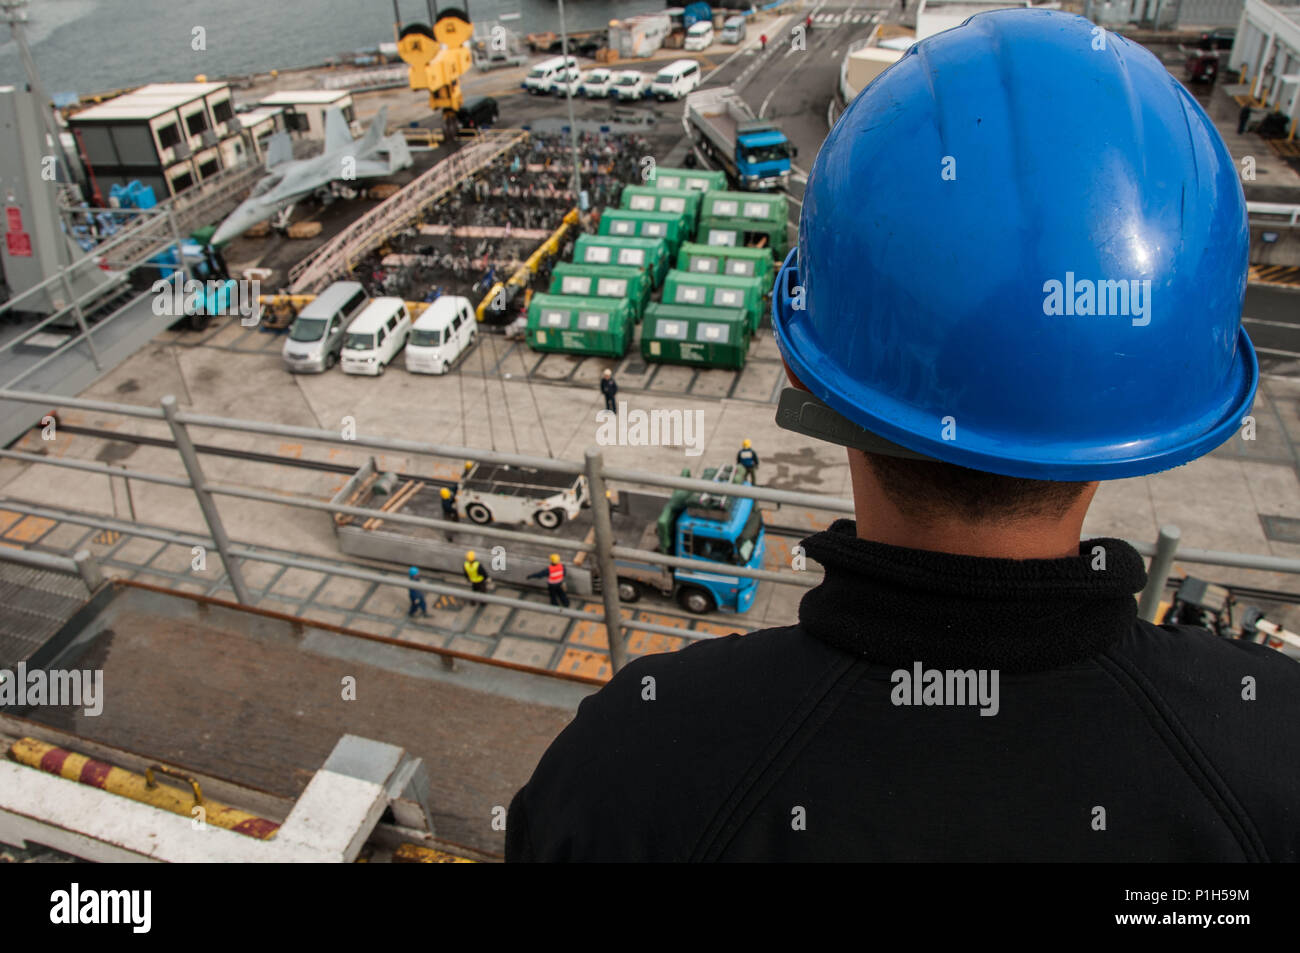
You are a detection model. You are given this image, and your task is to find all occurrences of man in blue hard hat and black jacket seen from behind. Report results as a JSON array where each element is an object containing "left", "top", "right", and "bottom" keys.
[{"left": 506, "top": 9, "right": 1300, "bottom": 861}]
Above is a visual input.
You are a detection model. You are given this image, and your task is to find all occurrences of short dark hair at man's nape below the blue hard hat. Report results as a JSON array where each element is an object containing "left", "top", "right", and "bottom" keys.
[{"left": 863, "top": 454, "right": 1088, "bottom": 523}]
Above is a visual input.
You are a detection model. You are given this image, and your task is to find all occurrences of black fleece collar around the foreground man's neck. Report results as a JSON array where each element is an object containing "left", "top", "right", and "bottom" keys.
[{"left": 800, "top": 520, "right": 1147, "bottom": 672}]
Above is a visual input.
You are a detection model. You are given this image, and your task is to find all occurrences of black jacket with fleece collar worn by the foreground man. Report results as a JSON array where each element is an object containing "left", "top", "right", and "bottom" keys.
[{"left": 506, "top": 520, "right": 1300, "bottom": 861}]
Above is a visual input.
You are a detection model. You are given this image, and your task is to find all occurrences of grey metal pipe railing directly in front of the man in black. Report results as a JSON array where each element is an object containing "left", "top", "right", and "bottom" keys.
[{"left": 0, "top": 390, "right": 1300, "bottom": 671}]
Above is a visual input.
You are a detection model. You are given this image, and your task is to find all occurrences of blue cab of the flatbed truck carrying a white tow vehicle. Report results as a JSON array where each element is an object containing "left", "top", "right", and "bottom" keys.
[{"left": 615, "top": 464, "right": 766, "bottom": 614}]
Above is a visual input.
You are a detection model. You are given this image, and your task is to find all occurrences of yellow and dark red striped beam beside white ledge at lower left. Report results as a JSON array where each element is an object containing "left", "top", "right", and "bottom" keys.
[{"left": 9, "top": 738, "right": 280, "bottom": 840}]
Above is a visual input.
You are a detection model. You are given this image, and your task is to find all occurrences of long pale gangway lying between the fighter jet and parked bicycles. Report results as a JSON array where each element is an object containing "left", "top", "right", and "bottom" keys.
[{"left": 289, "top": 129, "right": 528, "bottom": 294}]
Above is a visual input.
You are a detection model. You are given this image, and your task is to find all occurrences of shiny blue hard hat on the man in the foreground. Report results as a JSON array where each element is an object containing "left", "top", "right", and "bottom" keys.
[{"left": 772, "top": 9, "right": 1258, "bottom": 480}]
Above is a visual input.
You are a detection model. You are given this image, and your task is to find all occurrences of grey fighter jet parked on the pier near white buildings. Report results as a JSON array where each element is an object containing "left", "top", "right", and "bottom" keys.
[{"left": 212, "top": 107, "right": 412, "bottom": 244}]
